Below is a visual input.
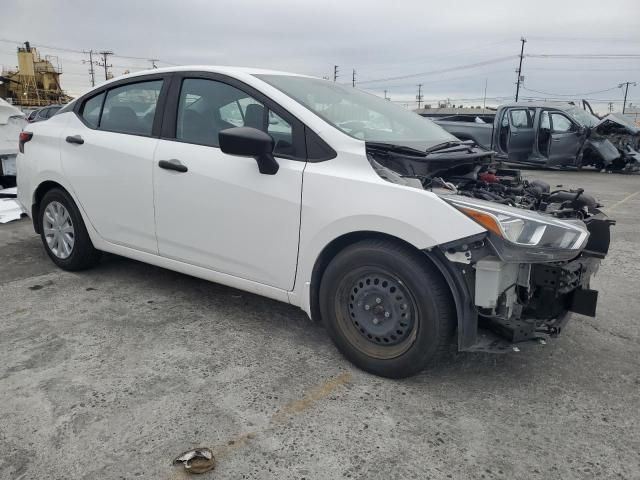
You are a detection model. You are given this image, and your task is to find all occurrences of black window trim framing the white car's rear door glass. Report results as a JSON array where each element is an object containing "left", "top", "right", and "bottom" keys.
[{"left": 73, "top": 72, "right": 174, "bottom": 138}]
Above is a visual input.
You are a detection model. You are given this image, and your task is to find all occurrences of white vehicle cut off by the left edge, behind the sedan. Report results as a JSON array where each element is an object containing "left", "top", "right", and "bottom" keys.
[{"left": 0, "top": 98, "right": 27, "bottom": 188}]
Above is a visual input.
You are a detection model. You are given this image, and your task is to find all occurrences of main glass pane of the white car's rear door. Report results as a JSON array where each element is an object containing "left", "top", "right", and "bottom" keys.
[{"left": 99, "top": 80, "right": 162, "bottom": 135}]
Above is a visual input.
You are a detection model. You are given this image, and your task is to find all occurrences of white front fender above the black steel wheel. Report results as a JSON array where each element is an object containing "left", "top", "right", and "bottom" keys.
[{"left": 290, "top": 156, "right": 485, "bottom": 315}]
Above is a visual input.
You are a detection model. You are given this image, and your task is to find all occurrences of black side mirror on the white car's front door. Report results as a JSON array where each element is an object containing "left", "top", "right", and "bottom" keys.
[{"left": 218, "top": 127, "right": 280, "bottom": 175}]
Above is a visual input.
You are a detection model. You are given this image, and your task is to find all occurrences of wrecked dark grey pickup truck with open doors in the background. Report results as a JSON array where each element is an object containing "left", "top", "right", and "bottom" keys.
[{"left": 435, "top": 102, "right": 640, "bottom": 173}]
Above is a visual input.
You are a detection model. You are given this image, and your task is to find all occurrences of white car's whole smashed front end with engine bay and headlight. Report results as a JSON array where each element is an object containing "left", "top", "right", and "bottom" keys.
[{"left": 368, "top": 142, "right": 615, "bottom": 353}]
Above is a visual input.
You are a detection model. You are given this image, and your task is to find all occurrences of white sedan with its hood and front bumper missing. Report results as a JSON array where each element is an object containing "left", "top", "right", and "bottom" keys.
[{"left": 18, "top": 67, "right": 612, "bottom": 377}]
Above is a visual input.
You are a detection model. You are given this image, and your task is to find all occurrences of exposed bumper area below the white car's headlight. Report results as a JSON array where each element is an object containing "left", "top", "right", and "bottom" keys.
[{"left": 438, "top": 210, "right": 613, "bottom": 353}]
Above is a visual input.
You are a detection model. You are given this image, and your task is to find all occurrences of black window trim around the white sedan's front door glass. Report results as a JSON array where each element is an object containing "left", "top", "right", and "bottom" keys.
[{"left": 160, "top": 71, "right": 316, "bottom": 162}]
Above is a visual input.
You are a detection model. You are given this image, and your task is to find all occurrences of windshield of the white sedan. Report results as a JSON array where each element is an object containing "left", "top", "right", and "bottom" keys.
[{"left": 256, "top": 75, "right": 457, "bottom": 150}]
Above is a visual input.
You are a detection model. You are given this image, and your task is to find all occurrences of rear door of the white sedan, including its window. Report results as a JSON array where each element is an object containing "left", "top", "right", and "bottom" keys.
[{"left": 60, "top": 75, "right": 168, "bottom": 253}]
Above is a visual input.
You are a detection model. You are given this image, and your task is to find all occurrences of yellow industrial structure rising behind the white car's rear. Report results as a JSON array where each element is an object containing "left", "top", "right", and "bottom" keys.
[{"left": 0, "top": 42, "right": 71, "bottom": 107}]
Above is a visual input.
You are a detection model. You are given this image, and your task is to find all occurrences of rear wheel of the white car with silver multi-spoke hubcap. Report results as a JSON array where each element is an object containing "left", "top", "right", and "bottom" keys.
[{"left": 37, "top": 188, "right": 100, "bottom": 271}]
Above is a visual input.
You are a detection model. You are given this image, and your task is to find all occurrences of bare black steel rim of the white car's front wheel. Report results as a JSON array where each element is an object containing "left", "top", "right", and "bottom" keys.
[{"left": 336, "top": 267, "right": 418, "bottom": 359}]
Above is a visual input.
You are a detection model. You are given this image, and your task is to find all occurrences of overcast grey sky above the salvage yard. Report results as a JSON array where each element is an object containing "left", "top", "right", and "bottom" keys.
[{"left": 0, "top": 0, "right": 640, "bottom": 111}]
